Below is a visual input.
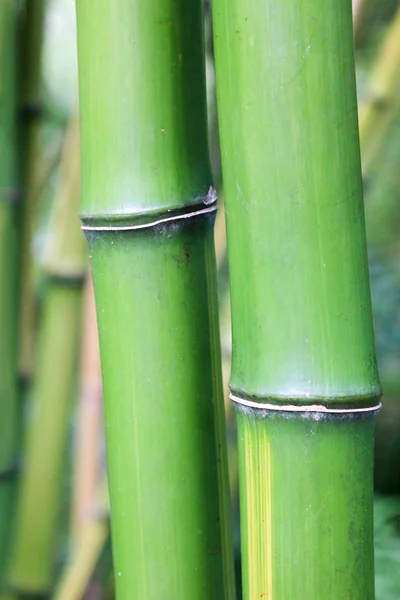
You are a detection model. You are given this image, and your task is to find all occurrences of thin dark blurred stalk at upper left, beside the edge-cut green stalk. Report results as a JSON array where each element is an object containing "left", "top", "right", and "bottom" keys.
[{"left": 19, "top": 0, "right": 46, "bottom": 381}]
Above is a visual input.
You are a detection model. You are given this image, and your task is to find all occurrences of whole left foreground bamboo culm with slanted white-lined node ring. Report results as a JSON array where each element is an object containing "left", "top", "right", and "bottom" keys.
[{"left": 76, "top": 0, "right": 234, "bottom": 600}]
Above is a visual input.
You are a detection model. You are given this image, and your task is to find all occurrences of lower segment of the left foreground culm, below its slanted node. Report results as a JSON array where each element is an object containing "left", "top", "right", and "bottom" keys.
[{"left": 89, "top": 217, "right": 234, "bottom": 600}]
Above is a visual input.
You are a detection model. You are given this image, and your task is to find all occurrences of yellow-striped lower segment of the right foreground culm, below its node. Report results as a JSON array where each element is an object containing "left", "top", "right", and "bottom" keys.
[{"left": 237, "top": 409, "right": 375, "bottom": 600}]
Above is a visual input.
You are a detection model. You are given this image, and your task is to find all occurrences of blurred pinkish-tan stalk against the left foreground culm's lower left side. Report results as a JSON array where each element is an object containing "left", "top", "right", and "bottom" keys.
[{"left": 71, "top": 276, "right": 103, "bottom": 544}]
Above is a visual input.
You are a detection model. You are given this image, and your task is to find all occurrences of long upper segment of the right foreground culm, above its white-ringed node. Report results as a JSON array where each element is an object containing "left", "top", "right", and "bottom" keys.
[{"left": 213, "top": 0, "right": 380, "bottom": 404}]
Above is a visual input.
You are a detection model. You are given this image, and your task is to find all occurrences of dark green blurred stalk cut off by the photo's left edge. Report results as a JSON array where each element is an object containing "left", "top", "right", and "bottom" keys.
[{"left": 0, "top": 0, "right": 19, "bottom": 586}]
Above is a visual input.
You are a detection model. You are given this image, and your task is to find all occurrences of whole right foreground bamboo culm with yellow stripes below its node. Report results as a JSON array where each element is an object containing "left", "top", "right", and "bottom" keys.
[{"left": 213, "top": 0, "right": 381, "bottom": 600}]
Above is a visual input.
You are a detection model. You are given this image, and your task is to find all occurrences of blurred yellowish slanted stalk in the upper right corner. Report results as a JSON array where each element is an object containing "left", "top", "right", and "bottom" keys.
[{"left": 359, "top": 8, "right": 400, "bottom": 177}]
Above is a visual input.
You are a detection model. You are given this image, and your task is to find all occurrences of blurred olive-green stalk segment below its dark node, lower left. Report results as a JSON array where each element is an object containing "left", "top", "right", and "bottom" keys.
[{"left": 8, "top": 282, "right": 82, "bottom": 594}]
